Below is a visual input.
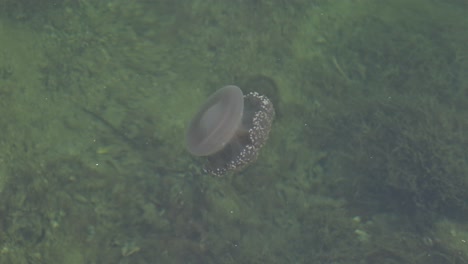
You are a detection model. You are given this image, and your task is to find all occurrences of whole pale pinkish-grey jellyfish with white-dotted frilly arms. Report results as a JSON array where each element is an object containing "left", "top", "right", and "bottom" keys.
[{"left": 186, "top": 85, "right": 275, "bottom": 176}]
